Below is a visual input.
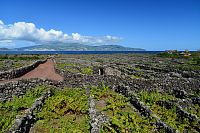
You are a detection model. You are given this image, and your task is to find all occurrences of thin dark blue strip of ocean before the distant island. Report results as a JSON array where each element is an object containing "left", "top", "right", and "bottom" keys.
[{"left": 0, "top": 51, "right": 163, "bottom": 55}]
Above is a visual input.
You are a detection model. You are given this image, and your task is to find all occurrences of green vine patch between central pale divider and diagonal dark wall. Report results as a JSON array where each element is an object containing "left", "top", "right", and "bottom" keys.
[{"left": 91, "top": 85, "right": 155, "bottom": 133}]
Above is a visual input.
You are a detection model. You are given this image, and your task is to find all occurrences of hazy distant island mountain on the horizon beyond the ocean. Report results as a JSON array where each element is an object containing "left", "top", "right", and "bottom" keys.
[{"left": 15, "top": 43, "right": 145, "bottom": 51}]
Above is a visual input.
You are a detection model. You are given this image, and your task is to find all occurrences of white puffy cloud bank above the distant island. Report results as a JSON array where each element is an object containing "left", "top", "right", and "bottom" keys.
[{"left": 0, "top": 20, "right": 121, "bottom": 45}]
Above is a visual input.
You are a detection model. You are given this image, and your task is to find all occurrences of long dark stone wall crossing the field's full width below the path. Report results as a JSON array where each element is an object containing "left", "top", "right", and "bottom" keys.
[{"left": 0, "top": 64, "right": 200, "bottom": 101}]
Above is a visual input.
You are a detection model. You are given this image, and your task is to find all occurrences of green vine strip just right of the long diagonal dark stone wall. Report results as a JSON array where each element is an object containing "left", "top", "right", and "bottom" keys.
[{"left": 138, "top": 91, "right": 197, "bottom": 132}]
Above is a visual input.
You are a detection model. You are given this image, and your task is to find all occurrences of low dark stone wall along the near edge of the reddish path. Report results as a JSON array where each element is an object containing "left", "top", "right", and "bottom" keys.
[{"left": 0, "top": 79, "right": 63, "bottom": 101}]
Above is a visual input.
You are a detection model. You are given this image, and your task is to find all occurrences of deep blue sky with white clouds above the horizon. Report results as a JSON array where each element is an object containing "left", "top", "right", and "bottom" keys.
[{"left": 0, "top": 0, "right": 200, "bottom": 50}]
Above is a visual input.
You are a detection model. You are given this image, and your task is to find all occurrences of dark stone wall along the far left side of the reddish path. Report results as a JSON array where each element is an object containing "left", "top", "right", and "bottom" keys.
[{"left": 0, "top": 60, "right": 47, "bottom": 80}]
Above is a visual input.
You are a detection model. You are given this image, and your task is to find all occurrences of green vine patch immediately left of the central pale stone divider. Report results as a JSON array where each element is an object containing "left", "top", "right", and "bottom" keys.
[{"left": 34, "top": 89, "right": 90, "bottom": 133}]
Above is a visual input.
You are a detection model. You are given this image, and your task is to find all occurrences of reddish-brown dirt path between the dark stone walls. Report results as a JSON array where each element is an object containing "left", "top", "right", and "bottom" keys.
[{"left": 0, "top": 59, "right": 63, "bottom": 83}]
